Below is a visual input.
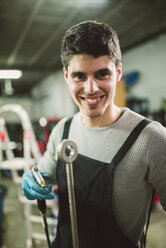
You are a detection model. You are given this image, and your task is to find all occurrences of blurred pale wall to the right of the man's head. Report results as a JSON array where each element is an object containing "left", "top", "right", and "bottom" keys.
[{"left": 122, "top": 35, "right": 166, "bottom": 111}]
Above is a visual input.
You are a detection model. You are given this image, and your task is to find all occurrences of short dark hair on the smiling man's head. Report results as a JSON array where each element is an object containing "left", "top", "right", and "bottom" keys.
[{"left": 61, "top": 21, "right": 121, "bottom": 69}]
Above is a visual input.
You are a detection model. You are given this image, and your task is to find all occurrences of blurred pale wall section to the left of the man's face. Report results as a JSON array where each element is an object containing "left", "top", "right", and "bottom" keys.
[{"left": 32, "top": 71, "right": 75, "bottom": 118}]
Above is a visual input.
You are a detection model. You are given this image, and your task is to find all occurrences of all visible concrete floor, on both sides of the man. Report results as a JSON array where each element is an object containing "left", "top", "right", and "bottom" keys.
[{"left": 1, "top": 175, "right": 166, "bottom": 248}]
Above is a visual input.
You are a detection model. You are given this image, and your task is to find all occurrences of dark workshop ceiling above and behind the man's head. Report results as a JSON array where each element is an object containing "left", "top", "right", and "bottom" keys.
[{"left": 0, "top": 0, "right": 166, "bottom": 96}]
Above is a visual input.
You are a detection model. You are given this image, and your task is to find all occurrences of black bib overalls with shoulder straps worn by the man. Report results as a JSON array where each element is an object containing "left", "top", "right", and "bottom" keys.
[{"left": 52, "top": 119, "right": 149, "bottom": 248}]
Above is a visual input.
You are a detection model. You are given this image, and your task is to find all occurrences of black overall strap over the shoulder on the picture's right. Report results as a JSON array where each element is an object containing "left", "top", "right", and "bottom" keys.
[{"left": 111, "top": 118, "right": 151, "bottom": 168}]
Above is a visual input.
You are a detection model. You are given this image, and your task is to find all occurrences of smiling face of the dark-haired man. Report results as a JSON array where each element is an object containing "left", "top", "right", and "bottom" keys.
[{"left": 64, "top": 54, "right": 122, "bottom": 126}]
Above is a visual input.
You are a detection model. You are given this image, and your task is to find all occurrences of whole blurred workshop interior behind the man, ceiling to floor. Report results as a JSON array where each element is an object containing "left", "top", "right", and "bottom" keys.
[{"left": 0, "top": 0, "right": 166, "bottom": 248}]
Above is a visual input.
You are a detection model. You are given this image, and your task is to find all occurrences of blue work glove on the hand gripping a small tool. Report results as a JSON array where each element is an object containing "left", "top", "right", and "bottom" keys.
[{"left": 21, "top": 171, "right": 54, "bottom": 200}]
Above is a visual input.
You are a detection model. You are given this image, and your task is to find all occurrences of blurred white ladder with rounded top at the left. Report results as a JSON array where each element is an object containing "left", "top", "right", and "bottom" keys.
[{"left": 0, "top": 104, "right": 57, "bottom": 248}]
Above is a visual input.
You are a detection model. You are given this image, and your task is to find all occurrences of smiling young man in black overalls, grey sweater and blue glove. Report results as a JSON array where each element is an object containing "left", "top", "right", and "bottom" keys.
[{"left": 22, "top": 21, "right": 166, "bottom": 248}]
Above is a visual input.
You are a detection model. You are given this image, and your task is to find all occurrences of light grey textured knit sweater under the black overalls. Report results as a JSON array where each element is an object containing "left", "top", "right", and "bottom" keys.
[{"left": 39, "top": 108, "right": 166, "bottom": 243}]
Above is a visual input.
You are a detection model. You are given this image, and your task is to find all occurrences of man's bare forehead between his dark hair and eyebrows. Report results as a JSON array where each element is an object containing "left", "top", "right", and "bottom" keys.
[{"left": 68, "top": 54, "right": 115, "bottom": 73}]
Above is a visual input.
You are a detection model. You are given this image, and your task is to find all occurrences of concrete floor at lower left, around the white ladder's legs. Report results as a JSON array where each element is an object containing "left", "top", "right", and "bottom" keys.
[{"left": 1, "top": 178, "right": 50, "bottom": 248}]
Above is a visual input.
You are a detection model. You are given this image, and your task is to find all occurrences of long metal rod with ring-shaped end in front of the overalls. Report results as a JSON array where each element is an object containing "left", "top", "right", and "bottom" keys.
[{"left": 58, "top": 139, "right": 79, "bottom": 248}]
